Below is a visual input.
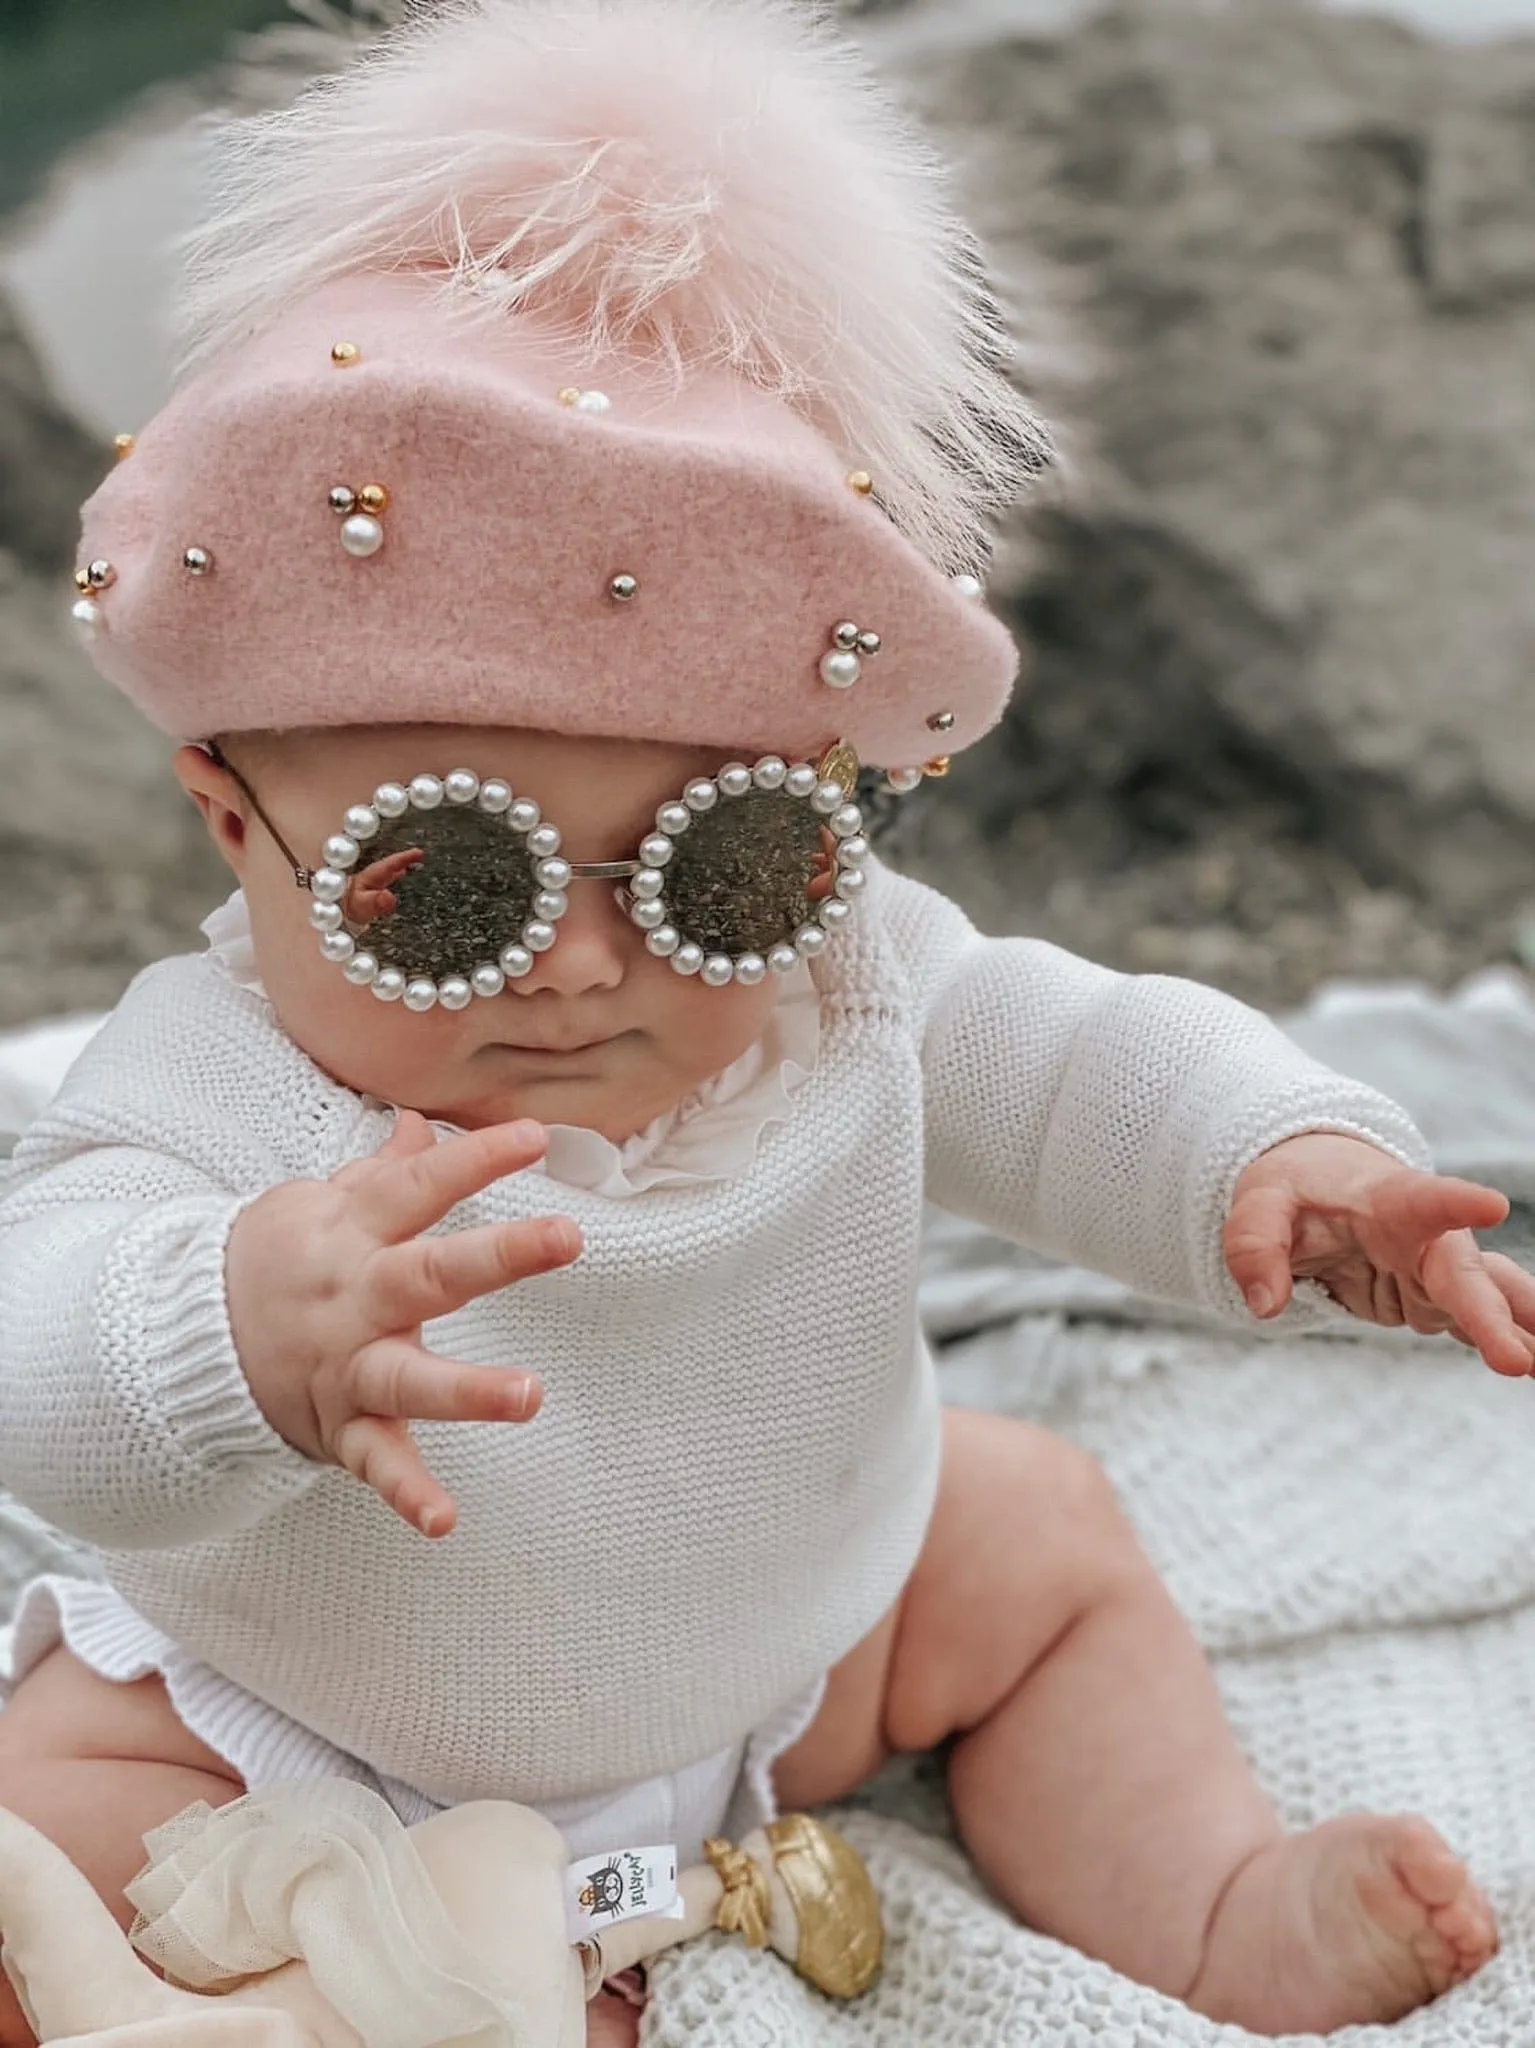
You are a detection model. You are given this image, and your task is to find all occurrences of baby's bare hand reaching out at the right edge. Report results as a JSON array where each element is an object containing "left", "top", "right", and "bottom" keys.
[{"left": 1226, "top": 1130, "right": 1535, "bottom": 1376}]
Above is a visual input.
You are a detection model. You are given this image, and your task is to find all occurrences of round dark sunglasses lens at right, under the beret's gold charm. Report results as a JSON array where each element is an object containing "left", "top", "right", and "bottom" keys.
[{"left": 665, "top": 788, "right": 827, "bottom": 956}]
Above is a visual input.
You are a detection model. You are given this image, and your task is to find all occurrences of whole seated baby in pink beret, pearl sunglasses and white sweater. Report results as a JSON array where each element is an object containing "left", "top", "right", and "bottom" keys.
[{"left": 0, "top": 0, "right": 1535, "bottom": 2048}]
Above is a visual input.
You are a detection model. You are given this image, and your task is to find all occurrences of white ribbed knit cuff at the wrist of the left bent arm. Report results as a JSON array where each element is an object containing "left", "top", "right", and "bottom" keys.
[{"left": 96, "top": 1196, "right": 319, "bottom": 1497}]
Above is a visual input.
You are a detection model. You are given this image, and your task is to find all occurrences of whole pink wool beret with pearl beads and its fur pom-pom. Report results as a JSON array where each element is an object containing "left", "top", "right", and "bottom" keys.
[{"left": 66, "top": 0, "right": 1048, "bottom": 768}]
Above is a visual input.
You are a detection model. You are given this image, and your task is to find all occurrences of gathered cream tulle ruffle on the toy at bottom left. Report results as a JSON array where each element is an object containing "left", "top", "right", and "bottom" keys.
[{"left": 127, "top": 1778, "right": 538, "bottom": 2048}]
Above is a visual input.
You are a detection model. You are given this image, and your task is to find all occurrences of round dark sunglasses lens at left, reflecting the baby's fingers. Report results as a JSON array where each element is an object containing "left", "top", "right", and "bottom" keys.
[{"left": 352, "top": 805, "right": 538, "bottom": 981}]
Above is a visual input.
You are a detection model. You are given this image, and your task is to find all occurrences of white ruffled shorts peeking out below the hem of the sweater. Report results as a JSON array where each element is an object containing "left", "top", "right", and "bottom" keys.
[{"left": 0, "top": 1575, "right": 825, "bottom": 1868}]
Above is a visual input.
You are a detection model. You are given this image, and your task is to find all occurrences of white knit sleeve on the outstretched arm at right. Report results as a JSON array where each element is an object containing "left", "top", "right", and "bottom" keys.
[{"left": 886, "top": 879, "right": 1429, "bottom": 1313}]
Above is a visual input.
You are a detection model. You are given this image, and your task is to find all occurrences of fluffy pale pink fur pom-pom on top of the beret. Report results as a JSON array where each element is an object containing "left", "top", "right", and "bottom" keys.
[{"left": 182, "top": 0, "right": 1048, "bottom": 569}]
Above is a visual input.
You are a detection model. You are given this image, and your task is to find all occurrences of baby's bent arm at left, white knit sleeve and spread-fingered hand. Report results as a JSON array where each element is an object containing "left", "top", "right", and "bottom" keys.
[{"left": 0, "top": 1015, "right": 579, "bottom": 1550}]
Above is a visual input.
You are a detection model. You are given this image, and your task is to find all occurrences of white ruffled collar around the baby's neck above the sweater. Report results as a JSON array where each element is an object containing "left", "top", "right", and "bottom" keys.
[{"left": 213, "top": 889, "right": 821, "bottom": 1200}]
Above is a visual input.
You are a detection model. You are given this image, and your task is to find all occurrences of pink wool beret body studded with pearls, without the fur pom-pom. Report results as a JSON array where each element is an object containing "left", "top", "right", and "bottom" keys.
[{"left": 84, "top": 276, "right": 1017, "bottom": 766}]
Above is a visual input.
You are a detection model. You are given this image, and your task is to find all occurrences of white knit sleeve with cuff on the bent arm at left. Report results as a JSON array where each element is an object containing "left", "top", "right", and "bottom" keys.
[{"left": 0, "top": 1133, "right": 319, "bottom": 1550}]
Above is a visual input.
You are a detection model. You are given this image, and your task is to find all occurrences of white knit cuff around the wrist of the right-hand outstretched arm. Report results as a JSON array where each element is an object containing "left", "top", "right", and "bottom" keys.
[{"left": 1189, "top": 1067, "right": 1433, "bottom": 1329}]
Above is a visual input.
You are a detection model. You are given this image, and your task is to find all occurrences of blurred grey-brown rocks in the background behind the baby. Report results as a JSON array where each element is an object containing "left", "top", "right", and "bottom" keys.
[{"left": 0, "top": 0, "right": 1535, "bottom": 1028}]
